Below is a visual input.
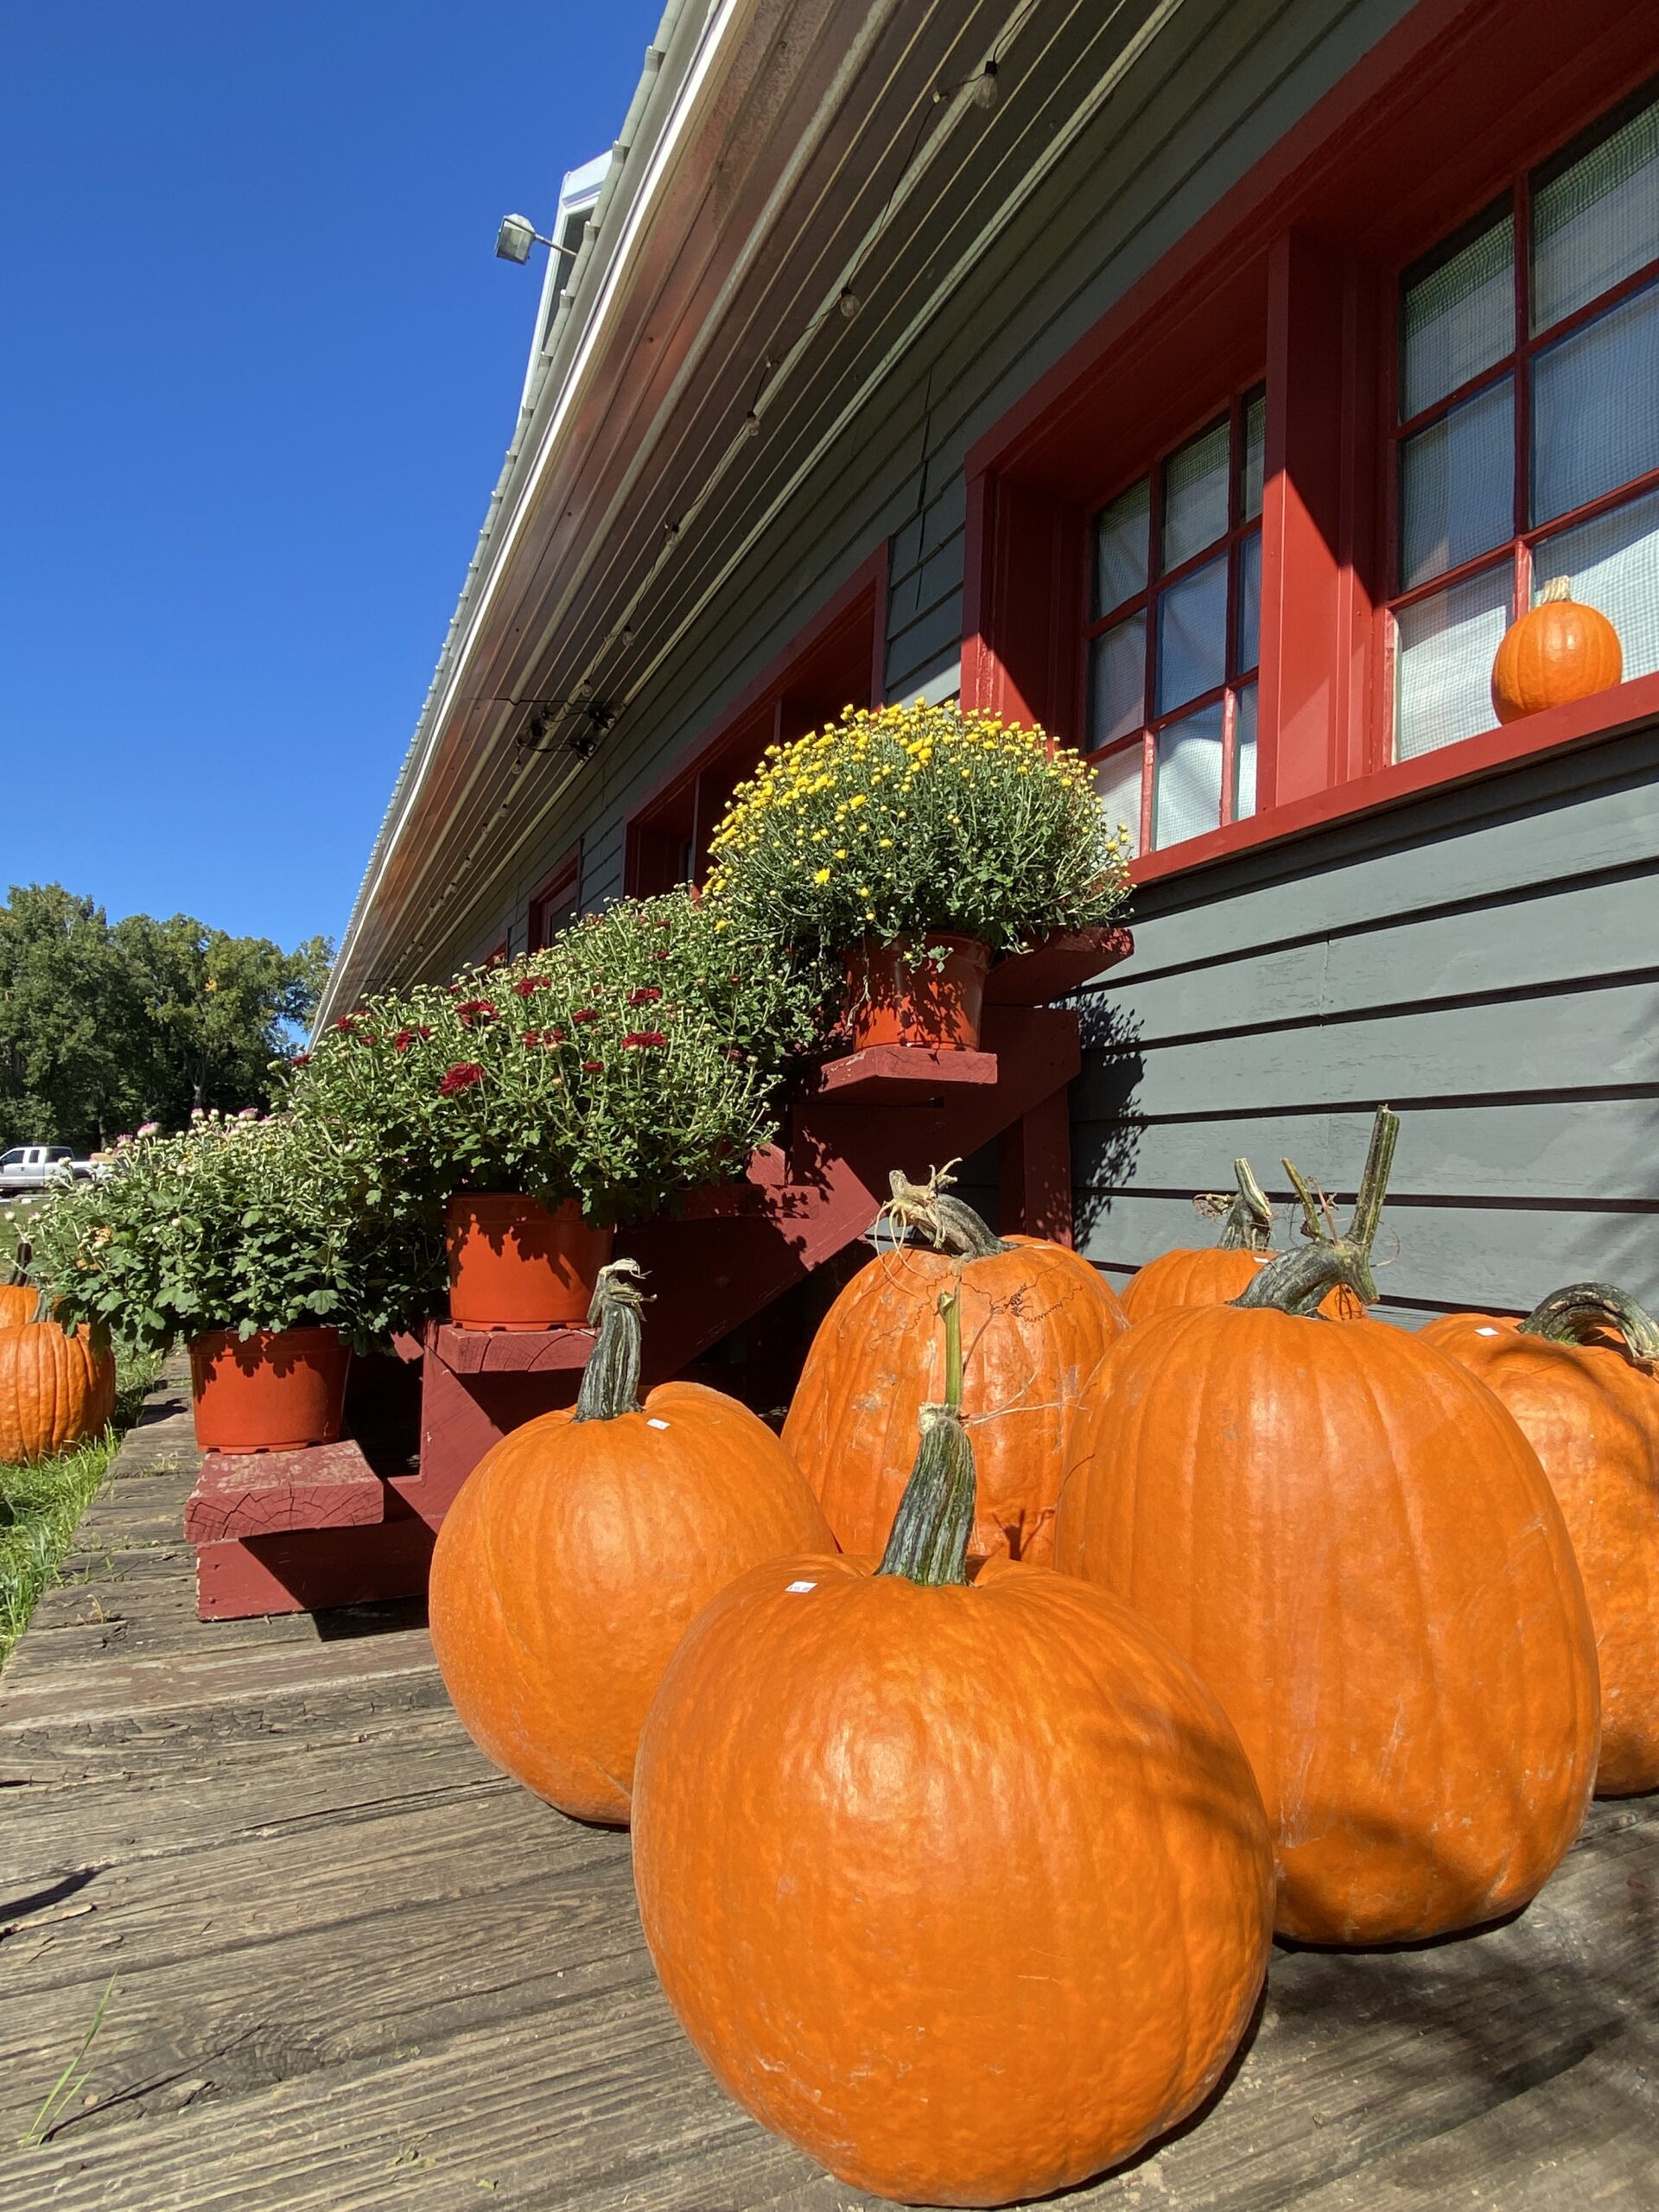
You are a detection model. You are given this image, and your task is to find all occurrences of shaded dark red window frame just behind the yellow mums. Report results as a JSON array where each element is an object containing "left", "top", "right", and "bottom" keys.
[{"left": 624, "top": 540, "right": 887, "bottom": 893}]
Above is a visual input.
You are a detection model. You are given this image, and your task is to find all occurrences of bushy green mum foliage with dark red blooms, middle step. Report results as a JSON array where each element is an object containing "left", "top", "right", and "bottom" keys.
[{"left": 288, "top": 892, "right": 823, "bottom": 1234}]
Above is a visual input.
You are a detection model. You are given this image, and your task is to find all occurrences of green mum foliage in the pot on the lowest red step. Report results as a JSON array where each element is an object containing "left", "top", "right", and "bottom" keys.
[{"left": 29, "top": 1110, "right": 442, "bottom": 1351}]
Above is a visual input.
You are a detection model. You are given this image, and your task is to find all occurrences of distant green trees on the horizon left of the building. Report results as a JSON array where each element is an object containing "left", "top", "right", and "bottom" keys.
[{"left": 0, "top": 882, "right": 334, "bottom": 1153}]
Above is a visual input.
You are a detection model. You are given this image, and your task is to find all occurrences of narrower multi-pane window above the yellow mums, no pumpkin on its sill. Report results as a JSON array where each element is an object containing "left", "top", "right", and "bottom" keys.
[{"left": 1086, "top": 390, "right": 1265, "bottom": 852}]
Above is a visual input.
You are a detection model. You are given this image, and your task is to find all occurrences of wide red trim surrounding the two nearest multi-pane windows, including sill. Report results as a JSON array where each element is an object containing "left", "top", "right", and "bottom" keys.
[{"left": 963, "top": 0, "right": 1659, "bottom": 878}]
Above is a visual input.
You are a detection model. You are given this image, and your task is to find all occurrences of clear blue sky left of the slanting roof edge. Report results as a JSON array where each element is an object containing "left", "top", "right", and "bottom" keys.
[{"left": 0, "top": 0, "right": 661, "bottom": 944}]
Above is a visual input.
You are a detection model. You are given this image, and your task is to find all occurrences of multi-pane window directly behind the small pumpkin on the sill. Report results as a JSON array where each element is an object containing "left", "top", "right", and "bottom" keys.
[{"left": 1391, "top": 102, "right": 1659, "bottom": 761}]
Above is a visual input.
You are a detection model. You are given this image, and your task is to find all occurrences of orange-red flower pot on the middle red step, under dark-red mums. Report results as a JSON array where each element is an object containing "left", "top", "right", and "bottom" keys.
[{"left": 445, "top": 1190, "right": 611, "bottom": 1330}]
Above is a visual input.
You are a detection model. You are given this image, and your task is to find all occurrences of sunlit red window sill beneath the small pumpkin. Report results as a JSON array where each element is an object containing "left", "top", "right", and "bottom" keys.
[{"left": 1130, "top": 675, "right": 1659, "bottom": 882}]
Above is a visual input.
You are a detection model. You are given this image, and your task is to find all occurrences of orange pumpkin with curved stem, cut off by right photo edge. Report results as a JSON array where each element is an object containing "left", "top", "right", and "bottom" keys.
[{"left": 1422, "top": 1283, "right": 1659, "bottom": 1796}]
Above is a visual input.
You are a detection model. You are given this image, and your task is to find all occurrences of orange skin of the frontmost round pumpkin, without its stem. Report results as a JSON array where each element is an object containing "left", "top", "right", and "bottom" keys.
[{"left": 632, "top": 1548, "right": 1272, "bottom": 2205}]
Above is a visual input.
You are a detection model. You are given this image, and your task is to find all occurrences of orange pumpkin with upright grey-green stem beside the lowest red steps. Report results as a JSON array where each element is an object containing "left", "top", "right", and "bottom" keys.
[{"left": 429, "top": 1261, "right": 834, "bottom": 1822}]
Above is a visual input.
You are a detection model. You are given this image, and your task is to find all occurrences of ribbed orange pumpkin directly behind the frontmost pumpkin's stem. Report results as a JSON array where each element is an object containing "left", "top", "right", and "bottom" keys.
[{"left": 783, "top": 1170, "right": 1128, "bottom": 1561}]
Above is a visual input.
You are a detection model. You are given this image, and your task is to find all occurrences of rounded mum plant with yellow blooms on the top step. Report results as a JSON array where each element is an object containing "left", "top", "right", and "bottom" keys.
[{"left": 708, "top": 703, "right": 1128, "bottom": 953}]
